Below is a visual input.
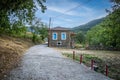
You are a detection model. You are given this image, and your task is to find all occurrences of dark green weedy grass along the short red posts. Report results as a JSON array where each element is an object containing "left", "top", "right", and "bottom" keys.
[{"left": 62, "top": 53, "right": 120, "bottom": 80}]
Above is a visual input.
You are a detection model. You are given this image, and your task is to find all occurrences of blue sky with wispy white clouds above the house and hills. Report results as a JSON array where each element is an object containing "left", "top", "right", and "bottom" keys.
[{"left": 35, "top": 0, "right": 112, "bottom": 28}]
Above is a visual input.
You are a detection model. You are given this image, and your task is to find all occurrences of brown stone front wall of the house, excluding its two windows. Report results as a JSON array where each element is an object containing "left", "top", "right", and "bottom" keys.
[{"left": 50, "top": 30, "right": 71, "bottom": 48}]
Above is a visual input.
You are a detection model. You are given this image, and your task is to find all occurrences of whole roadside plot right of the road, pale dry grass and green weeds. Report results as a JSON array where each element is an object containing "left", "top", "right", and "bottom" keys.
[{"left": 55, "top": 48, "right": 120, "bottom": 80}]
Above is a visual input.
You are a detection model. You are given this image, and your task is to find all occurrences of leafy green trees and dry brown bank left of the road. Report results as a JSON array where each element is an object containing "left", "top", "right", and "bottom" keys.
[{"left": 0, "top": 0, "right": 47, "bottom": 80}]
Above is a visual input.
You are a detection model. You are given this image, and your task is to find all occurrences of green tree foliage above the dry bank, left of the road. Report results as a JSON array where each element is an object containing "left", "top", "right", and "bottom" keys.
[{"left": 0, "top": 0, "right": 46, "bottom": 43}]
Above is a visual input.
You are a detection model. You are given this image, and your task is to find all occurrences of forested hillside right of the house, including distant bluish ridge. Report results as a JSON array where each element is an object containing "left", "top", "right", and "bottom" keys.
[{"left": 73, "top": 0, "right": 120, "bottom": 50}]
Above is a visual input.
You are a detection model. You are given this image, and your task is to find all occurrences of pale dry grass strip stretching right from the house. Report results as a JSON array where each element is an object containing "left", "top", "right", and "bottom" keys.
[{"left": 55, "top": 48, "right": 120, "bottom": 59}]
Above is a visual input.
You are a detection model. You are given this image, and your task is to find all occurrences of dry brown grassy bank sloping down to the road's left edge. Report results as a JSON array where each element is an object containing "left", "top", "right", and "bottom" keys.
[{"left": 0, "top": 35, "right": 34, "bottom": 79}]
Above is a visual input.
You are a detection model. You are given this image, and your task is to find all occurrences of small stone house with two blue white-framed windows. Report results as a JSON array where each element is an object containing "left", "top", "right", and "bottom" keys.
[{"left": 48, "top": 27, "right": 73, "bottom": 48}]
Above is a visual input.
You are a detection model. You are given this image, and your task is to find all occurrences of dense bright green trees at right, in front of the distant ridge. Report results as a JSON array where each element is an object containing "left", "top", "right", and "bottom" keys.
[{"left": 87, "top": 9, "right": 120, "bottom": 49}]
